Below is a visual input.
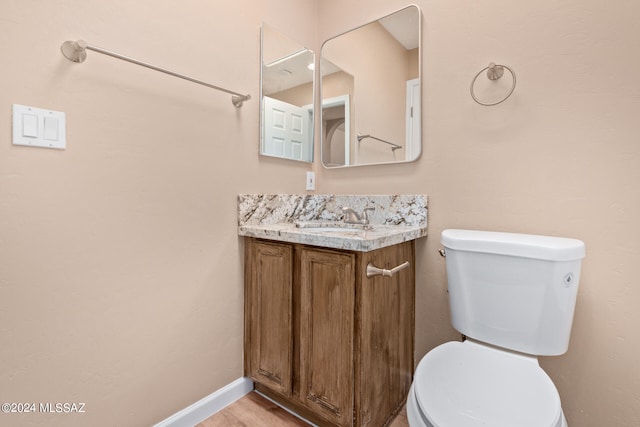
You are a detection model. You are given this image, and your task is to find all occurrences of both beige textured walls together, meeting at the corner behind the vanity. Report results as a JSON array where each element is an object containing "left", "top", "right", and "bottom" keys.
[{"left": 0, "top": 0, "right": 640, "bottom": 427}]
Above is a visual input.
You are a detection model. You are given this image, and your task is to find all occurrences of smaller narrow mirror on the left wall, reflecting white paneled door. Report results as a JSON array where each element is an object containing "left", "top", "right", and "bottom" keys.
[{"left": 260, "top": 23, "right": 315, "bottom": 162}]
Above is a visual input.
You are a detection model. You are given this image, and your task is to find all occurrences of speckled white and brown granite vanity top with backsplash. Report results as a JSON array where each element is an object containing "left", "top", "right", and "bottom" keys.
[{"left": 238, "top": 194, "right": 427, "bottom": 252}]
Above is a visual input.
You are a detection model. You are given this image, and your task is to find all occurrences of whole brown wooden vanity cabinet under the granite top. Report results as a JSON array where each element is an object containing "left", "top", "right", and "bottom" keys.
[{"left": 245, "top": 238, "right": 415, "bottom": 427}]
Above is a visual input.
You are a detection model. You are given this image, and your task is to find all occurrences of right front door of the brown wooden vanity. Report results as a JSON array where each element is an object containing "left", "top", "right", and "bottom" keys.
[{"left": 299, "top": 248, "right": 355, "bottom": 426}]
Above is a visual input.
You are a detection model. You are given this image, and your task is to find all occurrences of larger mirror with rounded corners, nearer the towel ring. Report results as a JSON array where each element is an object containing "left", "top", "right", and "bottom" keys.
[{"left": 320, "top": 5, "right": 422, "bottom": 168}]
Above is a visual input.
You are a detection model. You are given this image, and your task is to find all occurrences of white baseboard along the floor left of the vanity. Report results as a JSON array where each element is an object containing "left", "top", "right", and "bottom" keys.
[{"left": 154, "top": 377, "right": 253, "bottom": 427}]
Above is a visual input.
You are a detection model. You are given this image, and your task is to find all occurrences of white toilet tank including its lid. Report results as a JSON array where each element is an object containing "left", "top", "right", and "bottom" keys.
[{"left": 441, "top": 230, "right": 585, "bottom": 356}]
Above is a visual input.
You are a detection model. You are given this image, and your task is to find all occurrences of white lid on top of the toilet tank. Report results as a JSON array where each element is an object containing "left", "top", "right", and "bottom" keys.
[{"left": 441, "top": 229, "right": 585, "bottom": 261}]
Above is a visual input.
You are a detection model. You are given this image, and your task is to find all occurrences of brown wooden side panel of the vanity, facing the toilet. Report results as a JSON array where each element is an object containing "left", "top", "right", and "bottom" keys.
[{"left": 356, "top": 242, "right": 415, "bottom": 427}]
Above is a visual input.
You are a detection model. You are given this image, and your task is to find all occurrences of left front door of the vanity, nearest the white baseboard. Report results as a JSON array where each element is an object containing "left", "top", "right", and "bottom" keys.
[{"left": 245, "top": 239, "right": 293, "bottom": 396}]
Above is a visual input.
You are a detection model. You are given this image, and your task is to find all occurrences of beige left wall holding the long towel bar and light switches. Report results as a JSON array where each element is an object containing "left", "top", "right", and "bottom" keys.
[{"left": 0, "top": 0, "right": 316, "bottom": 426}]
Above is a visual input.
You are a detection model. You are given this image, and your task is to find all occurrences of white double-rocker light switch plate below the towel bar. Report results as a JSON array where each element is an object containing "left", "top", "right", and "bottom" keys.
[{"left": 13, "top": 104, "right": 67, "bottom": 150}]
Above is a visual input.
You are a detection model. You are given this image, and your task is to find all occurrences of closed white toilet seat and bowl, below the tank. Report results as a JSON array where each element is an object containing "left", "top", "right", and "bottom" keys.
[{"left": 413, "top": 340, "right": 563, "bottom": 427}]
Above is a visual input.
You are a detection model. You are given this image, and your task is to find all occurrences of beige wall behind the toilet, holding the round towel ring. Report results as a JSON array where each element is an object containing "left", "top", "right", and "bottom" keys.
[{"left": 318, "top": 0, "right": 640, "bottom": 427}]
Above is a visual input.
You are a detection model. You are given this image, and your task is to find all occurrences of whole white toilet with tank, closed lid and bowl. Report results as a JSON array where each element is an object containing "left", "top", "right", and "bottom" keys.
[{"left": 407, "top": 230, "right": 585, "bottom": 427}]
